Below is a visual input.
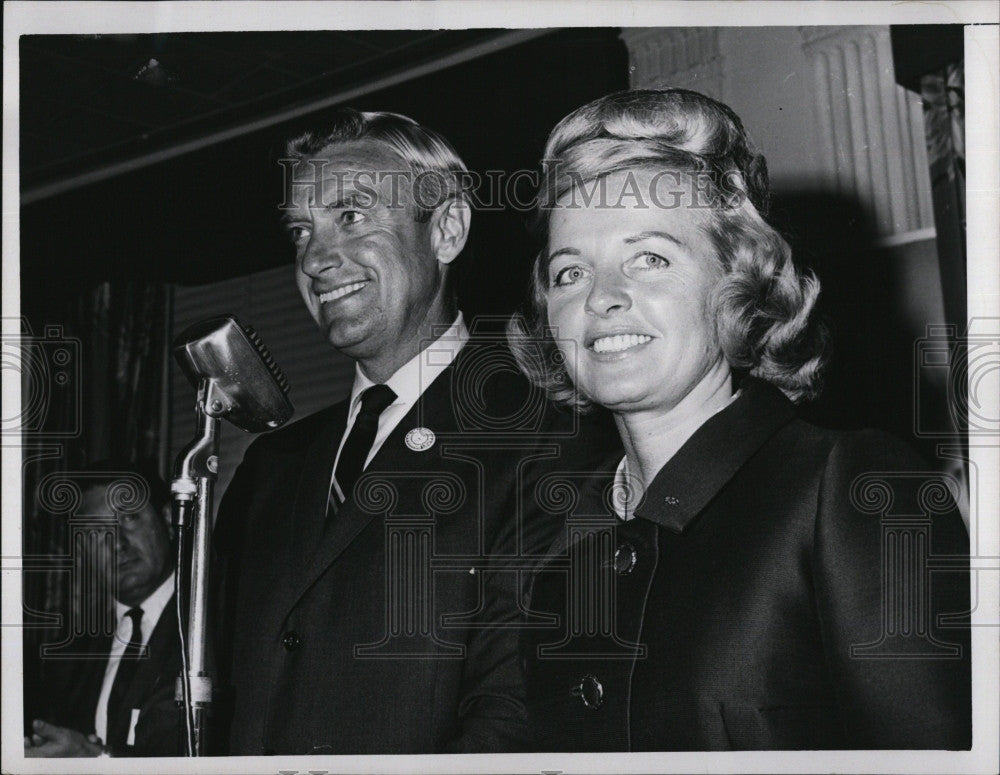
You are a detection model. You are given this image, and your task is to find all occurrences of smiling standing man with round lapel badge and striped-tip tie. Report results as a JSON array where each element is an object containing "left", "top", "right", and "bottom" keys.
[{"left": 215, "top": 106, "right": 608, "bottom": 754}]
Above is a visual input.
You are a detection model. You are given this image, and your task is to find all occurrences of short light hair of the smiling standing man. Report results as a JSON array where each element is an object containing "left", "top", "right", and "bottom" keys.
[{"left": 285, "top": 108, "right": 468, "bottom": 222}]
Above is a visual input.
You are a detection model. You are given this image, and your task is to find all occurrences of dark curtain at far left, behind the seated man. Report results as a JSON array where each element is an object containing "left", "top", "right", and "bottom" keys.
[{"left": 21, "top": 281, "right": 169, "bottom": 719}]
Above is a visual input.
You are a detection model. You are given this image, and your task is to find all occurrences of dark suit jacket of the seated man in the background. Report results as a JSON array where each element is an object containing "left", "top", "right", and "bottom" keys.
[{"left": 43, "top": 597, "right": 184, "bottom": 756}]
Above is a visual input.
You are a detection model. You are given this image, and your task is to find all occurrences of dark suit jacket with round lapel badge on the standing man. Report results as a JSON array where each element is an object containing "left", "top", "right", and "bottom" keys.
[{"left": 215, "top": 340, "right": 603, "bottom": 754}]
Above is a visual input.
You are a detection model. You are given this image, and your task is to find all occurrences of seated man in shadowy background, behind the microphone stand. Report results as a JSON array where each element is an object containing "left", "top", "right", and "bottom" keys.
[{"left": 24, "top": 461, "right": 181, "bottom": 757}]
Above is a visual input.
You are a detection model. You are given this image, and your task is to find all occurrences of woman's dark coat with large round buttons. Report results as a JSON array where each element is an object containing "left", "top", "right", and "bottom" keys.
[{"left": 523, "top": 380, "right": 971, "bottom": 751}]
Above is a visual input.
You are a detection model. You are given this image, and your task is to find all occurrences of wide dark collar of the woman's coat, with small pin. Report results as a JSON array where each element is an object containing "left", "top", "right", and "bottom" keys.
[{"left": 635, "top": 378, "right": 795, "bottom": 533}]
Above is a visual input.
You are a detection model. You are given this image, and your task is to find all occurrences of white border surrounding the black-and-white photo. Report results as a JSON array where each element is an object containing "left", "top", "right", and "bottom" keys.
[{"left": 0, "top": 0, "right": 1000, "bottom": 774}]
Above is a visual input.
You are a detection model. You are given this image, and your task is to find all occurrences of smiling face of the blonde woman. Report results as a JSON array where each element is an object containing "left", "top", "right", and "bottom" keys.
[{"left": 547, "top": 170, "right": 724, "bottom": 412}]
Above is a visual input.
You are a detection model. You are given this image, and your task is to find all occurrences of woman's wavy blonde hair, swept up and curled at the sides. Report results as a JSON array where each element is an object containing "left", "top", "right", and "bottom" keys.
[{"left": 508, "top": 89, "right": 827, "bottom": 409}]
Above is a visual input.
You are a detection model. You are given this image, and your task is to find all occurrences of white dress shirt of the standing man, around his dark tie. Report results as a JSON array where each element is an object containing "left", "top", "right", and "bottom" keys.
[{"left": 330, "top": 312, "right": 469, "bottom": 501}]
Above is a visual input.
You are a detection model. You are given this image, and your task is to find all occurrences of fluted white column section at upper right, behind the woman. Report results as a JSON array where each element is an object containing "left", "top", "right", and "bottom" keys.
[{"left": 799, "top": 27, "right": 934, "bottom": 241}]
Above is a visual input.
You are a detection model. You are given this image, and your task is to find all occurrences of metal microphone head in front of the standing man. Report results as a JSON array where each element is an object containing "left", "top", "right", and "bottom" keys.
[{"left": 172, "top": 315, "right": 293, "bottom": 433}]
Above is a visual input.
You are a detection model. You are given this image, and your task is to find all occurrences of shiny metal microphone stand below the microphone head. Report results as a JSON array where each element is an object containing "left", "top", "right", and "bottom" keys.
[{"left": 170, "top": 379, "right": 230, "bottom": 756}]
